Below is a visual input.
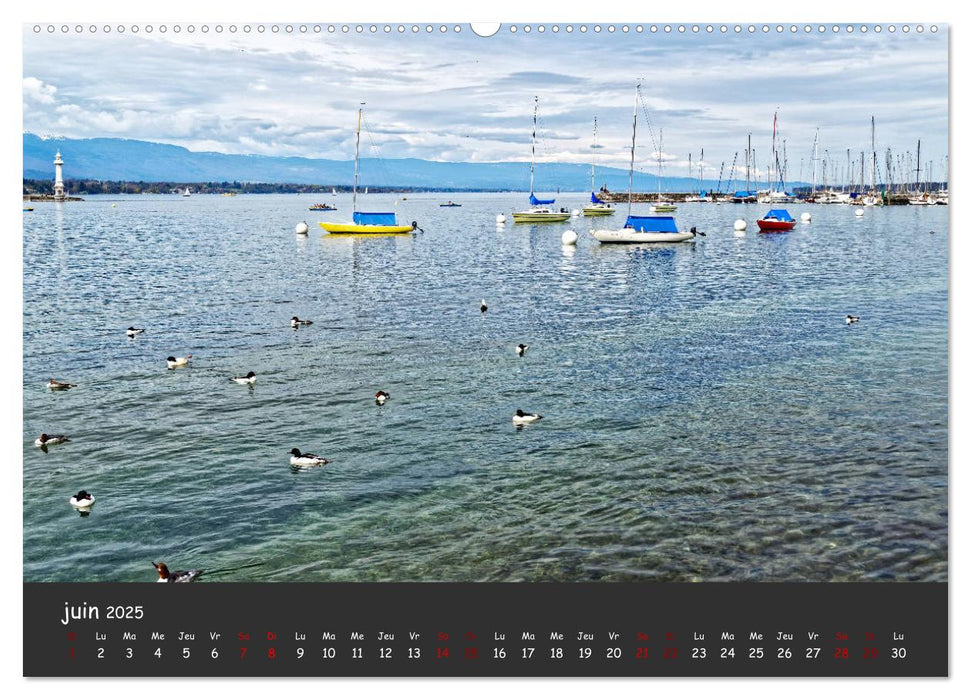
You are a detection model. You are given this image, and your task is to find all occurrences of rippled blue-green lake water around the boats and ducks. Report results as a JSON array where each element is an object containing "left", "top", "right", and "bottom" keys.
[{"left": 23, "top": 194, "right": 948, "bottom": 581}]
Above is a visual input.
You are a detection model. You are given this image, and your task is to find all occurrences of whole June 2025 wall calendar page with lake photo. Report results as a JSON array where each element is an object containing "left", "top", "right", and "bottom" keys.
[{"left": 21, "top": 12, "right": 950, "bottom": 678}]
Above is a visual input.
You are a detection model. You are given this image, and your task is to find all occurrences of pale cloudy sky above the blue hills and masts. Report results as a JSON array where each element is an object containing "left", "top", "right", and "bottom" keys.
[{"left": 23, "top": 23, "right": 948, "bottom": 180}]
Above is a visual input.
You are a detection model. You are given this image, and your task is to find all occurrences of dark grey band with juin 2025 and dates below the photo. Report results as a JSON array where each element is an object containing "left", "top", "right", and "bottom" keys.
[{"left": 24, "top": 583, "right": 948, "bottom": 677}]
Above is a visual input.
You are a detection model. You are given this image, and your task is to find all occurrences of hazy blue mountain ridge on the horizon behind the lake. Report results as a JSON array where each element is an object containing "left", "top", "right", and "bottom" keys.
[{"left": 23, "top": 133, "right": 780, "bottom": 192}]
